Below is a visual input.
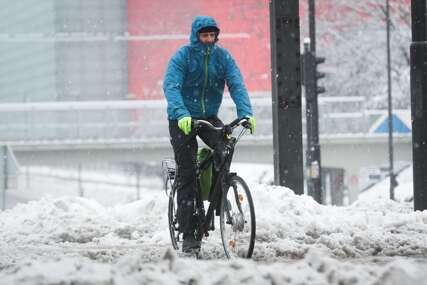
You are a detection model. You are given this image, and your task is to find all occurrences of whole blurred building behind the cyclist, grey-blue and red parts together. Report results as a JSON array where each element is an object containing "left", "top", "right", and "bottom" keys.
[{"left": 0, "top": 0, "right": 270, "bottom": 102}]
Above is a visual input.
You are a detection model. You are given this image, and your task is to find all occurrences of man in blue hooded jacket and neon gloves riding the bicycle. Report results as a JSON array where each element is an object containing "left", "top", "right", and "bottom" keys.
[{"left": 163, "top": 16, "right": 255, "bottom": 252}]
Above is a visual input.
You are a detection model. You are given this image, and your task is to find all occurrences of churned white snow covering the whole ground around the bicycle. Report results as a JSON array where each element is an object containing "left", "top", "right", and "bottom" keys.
[{"left": 0, "top": 165, "right": 427, "bottom": 284}]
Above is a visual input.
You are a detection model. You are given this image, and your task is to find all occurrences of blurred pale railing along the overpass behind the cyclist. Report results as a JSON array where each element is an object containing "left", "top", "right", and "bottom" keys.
[{"left": 0, "top": 96, "right": 409, "bottom": 145}]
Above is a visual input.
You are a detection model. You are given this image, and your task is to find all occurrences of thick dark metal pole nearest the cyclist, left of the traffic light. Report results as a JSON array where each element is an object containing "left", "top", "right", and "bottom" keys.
[{"left": 270, "top": 0, "right": 304, "bottom": 194}]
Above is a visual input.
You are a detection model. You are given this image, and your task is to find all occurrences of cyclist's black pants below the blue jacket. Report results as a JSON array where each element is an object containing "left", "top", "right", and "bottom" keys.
[{"left": 169, "top": 117, "right": 224, "bottom": 234}]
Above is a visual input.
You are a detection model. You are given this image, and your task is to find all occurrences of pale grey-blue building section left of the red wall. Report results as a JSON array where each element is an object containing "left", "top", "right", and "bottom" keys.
[{"left": 0, "top": 0, "right": 127, "bottom": 102}]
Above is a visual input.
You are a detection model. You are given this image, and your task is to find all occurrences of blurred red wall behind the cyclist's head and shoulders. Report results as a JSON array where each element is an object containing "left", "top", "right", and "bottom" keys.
[{"left": 127, "top": 0, "right": 271, "bottom": 99}]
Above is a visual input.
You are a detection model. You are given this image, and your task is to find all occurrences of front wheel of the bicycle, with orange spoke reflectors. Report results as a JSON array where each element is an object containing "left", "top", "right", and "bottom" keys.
[{"left": 220, "top": 176, "right": 256, "bottom": 258}]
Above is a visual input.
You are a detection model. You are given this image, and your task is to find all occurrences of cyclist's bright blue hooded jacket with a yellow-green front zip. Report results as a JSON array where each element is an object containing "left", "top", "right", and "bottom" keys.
[{"left": 163, "top": 16, "right": 252, "bottom": 120}]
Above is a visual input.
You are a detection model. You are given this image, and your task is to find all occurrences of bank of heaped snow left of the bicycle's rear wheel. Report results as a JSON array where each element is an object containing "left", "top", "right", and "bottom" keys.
[{"left": 0, "top": 192, "right": 166, "bottom": 245}]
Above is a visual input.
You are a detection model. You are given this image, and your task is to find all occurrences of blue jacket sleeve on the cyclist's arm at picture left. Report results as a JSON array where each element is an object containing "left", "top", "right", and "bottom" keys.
[{"left": 163, "top": 48, "right": 190, "bottom": 120}]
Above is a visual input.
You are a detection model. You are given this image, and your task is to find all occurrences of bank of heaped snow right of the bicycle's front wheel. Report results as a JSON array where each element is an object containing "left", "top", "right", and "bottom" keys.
[{"left": 254, "top": 186, "right": 427, "bottom": 259}]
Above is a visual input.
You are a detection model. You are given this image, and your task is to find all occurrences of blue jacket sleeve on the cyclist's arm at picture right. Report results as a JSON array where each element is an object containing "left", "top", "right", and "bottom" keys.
[{"left": 224, "top": 50, "right": 252, "bottom": 118}]
